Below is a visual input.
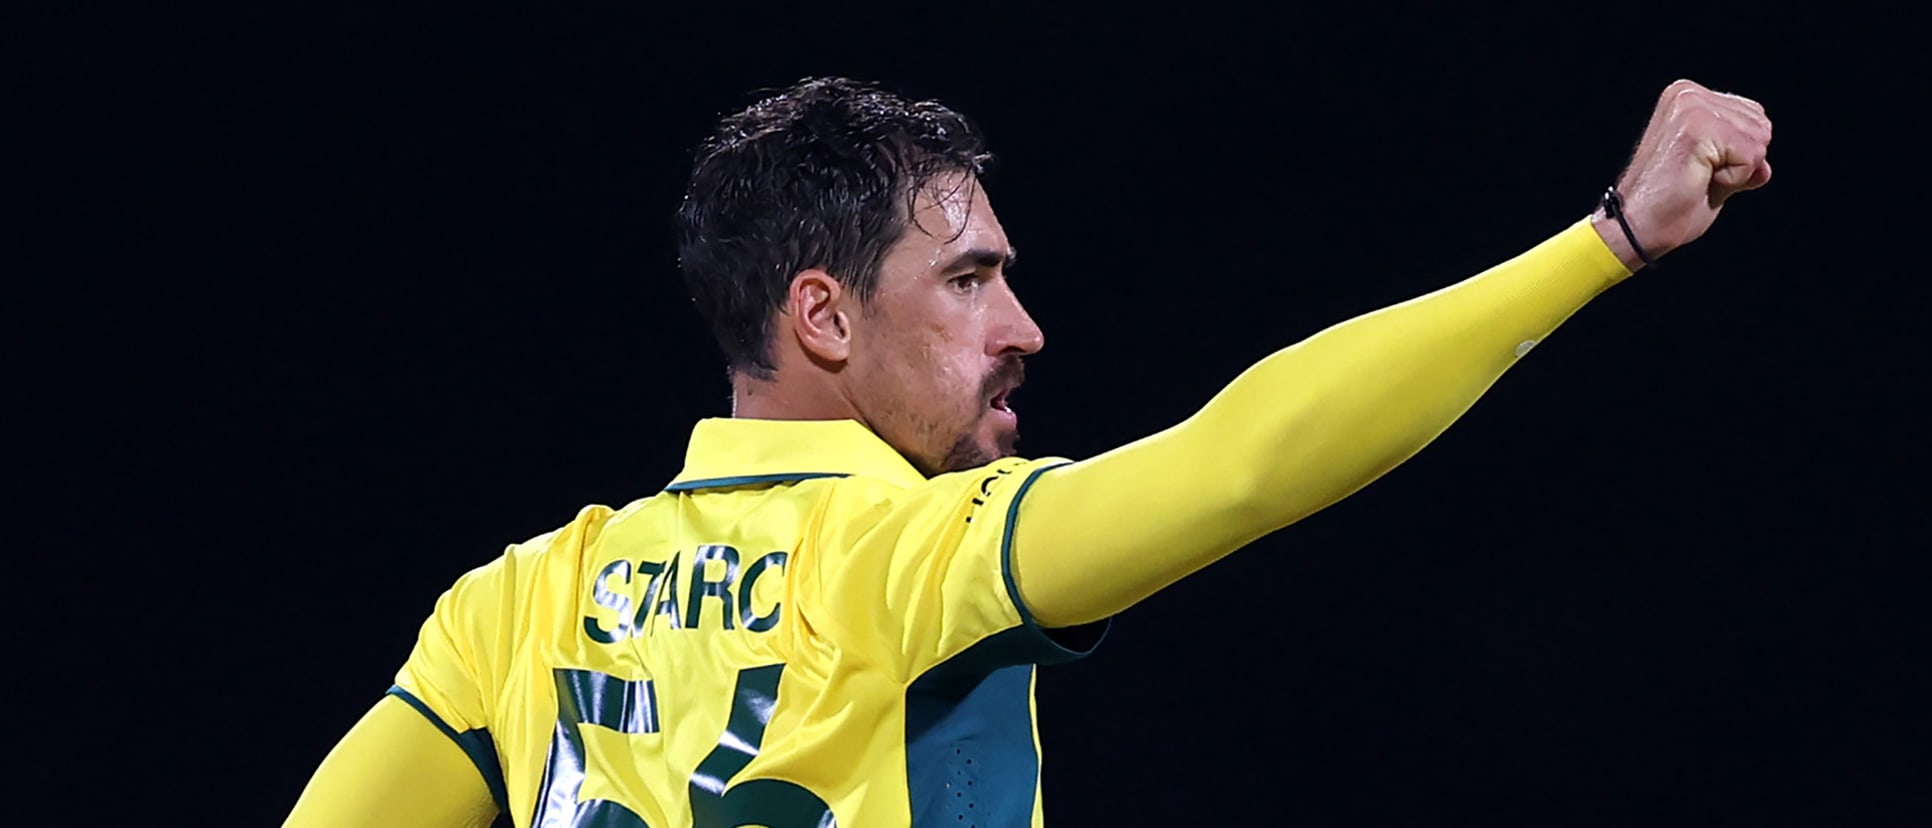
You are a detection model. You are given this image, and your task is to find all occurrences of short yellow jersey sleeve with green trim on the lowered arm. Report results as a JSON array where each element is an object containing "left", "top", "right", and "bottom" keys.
[{"left": 388, "top": 554, "right": 516, "bottom": 807}]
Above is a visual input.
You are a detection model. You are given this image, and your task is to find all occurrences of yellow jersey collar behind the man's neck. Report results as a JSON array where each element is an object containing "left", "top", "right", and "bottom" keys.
[{"left": 665, "top": 417, "right": 925, "bottom": 492}]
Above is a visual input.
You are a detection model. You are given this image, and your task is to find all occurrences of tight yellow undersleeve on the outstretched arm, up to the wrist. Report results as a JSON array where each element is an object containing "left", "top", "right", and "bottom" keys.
[{"left": 1012, "top": 220, "right": 1631, "bottom": 625}]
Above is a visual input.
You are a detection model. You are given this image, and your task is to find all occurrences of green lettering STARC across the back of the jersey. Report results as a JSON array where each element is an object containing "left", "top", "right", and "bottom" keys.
[{"left": 583, "top": 544, "right": 788, "bottom": 645}]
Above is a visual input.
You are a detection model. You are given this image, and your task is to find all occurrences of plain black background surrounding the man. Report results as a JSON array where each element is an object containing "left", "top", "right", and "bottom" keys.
[{"left": 0, "top": 4, "right": 1932, "bottom": 824}]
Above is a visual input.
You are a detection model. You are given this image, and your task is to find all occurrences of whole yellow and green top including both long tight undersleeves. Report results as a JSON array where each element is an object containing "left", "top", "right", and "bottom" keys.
[{"left": 288, "top": 218, "right": 1631, "bottom": 828}]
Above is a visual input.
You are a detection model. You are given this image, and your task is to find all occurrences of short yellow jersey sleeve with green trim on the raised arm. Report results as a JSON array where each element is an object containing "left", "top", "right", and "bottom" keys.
[{"left": 810, "top": 457, "right": 1107, "bottom": 681}]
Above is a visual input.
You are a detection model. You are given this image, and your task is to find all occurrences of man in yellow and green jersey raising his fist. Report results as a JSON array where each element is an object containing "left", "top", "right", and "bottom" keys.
[{"left": 288, "top": 79, "right": 1772, "bottom": 828}]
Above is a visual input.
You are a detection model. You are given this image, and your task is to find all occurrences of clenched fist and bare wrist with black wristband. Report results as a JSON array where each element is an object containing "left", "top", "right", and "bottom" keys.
[{"left": 1594, "top": 81, "right": 1772, "bottom": 270}]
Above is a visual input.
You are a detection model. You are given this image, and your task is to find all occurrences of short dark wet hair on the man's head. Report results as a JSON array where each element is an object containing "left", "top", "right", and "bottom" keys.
[{"left": 678, "top": 77, "right": 991, "bottom": 378}]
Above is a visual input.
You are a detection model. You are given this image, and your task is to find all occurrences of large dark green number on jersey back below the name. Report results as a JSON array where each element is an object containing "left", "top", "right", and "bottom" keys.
[{"left": 531, "top": 664, "right": 838, "bottom": 828}]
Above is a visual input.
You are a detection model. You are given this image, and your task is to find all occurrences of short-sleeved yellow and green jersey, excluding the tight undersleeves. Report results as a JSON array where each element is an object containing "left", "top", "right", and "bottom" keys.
[{"left": 390, "top": 419, "right": 1107, "bottom": 828}]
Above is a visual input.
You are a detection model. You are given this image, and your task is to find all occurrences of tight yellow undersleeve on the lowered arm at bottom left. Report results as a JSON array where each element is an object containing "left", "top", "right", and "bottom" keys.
[{"left": 284, "top": 697, "right": 497, "bottom": 828}]
